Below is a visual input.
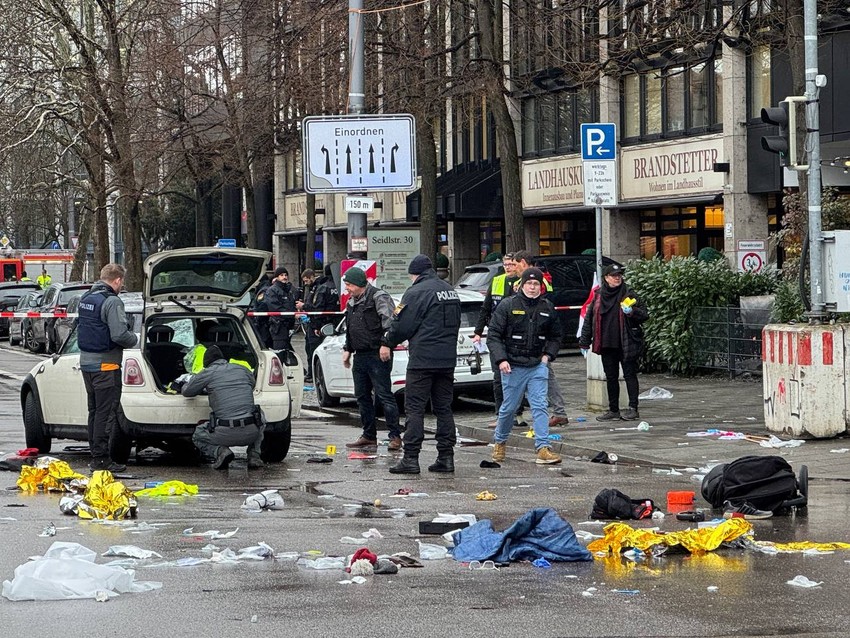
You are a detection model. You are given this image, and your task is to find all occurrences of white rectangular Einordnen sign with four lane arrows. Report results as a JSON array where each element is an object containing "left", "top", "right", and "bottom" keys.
[{"left": 301, "top": 114, "right": 416, "bottom": 193}]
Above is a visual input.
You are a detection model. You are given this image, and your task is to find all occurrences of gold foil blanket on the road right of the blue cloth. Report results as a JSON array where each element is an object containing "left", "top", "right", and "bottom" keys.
[{"left": 587, "top": 518, "right": 753, "bottom": 554}]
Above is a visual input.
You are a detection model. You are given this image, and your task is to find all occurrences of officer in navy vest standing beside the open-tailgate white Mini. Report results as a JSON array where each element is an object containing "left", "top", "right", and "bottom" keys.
[{"left": 77, "top": 264, "right": 139, "bottom": 472}]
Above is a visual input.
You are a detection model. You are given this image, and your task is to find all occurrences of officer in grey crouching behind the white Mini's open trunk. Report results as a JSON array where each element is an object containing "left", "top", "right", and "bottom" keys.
[{"left": 181, "top": 346, "right": 265, "bottom": 470}]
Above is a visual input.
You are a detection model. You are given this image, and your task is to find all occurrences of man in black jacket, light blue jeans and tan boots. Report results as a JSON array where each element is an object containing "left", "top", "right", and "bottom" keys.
[{"left": 487, "top": 268, "right": 561, "bottom": 465}]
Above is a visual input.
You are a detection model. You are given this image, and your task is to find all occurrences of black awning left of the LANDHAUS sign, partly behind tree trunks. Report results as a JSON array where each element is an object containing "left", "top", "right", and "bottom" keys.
[{"left": 407, "top": 160, "right": 504, "bottom": 221}]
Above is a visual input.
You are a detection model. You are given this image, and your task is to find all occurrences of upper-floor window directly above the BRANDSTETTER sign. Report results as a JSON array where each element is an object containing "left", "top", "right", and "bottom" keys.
[{"left": 621, "top": 58, "right": 723, "bottom": 143}]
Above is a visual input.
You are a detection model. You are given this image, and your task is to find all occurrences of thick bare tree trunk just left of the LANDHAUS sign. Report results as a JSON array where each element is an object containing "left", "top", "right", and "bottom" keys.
[{"left": 476, "top": 0, "right": 526, "bottom": 252}]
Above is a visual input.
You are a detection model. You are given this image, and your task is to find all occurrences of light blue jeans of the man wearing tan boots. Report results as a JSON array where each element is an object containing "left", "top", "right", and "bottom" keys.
[{"left": 493, "top": 363, "right": 551, "bottom": 450}]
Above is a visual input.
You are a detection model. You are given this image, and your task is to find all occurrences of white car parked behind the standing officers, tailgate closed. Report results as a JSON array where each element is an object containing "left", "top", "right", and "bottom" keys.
[{"left": 313, "top": 290, "right": 493, "bottom": 407}]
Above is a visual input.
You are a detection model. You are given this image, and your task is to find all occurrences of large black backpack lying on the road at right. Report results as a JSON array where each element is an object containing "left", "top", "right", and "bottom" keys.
[{"left": 701, "top": 456, "right": 808, "bottom": 512}]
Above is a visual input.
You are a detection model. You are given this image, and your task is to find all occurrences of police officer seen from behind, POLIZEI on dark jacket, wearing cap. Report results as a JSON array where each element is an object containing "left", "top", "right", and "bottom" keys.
[{"left": 388, "top": 255, "right": 461, "bottom": 474}]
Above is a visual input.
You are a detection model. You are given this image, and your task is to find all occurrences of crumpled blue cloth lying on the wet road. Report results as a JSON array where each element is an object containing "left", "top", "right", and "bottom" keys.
[{"left": 451, "top": 507, "right": 593, "bottom": 563}]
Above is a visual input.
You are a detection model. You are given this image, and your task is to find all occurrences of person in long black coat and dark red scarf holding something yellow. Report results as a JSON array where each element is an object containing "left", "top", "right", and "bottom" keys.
[{"left": 579, "top": 264, "right": 649, "bottom": 421}]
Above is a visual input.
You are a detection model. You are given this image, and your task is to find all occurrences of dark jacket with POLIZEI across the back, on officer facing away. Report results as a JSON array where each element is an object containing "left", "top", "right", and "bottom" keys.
[{"left": 386, "top": 269, "right": 461, "bottom": 370}]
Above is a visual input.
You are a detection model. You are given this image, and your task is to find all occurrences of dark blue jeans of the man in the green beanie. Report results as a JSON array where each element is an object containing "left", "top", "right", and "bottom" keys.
[{"left": 351, "top": 350, "right": 401, "bottom": 441}]
